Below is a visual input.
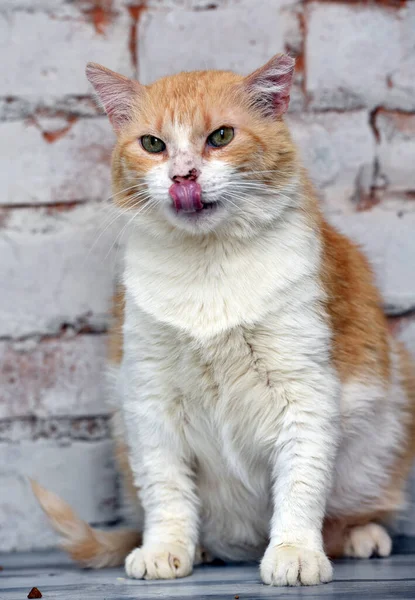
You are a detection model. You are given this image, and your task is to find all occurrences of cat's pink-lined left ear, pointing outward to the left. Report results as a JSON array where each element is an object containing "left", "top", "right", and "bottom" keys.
[{"left": 86, "top": 63, "right": 142, "bottom": 132}]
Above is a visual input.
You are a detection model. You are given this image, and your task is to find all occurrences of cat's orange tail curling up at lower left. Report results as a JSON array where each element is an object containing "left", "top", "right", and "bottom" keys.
[{"left": 30, "top": 480, "right": 141, "bottom": 569}]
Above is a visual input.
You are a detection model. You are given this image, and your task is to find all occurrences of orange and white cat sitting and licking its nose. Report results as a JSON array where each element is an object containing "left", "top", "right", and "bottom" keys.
[{"left": 33, "top": 54, "right": 415, "bottom": 586}]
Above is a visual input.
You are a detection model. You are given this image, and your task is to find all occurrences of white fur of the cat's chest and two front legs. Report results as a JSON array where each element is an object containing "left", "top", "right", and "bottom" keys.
[{"left": 116, "top": 193, "right": 338, "bottom": 583}]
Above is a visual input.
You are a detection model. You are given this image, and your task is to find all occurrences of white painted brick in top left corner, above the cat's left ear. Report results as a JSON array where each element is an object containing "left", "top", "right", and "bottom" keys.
[{"left": 0, "top": 3, "right": 133, "bottom": 96}]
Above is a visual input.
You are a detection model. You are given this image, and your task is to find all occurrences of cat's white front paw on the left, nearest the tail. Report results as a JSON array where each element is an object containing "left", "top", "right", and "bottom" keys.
[{"left": 125, "top": 544, "right": 193, "bottom": 579}]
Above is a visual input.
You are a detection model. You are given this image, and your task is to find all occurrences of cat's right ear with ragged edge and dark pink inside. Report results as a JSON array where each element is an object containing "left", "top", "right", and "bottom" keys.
[{"left": 244, "top": 54, "right": 295, "bottom": 117}]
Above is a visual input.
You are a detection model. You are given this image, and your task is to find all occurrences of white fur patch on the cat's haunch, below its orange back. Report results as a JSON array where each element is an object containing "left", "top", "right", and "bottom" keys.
[{"left": 327, "top": 345, "right": 407, "bottom": 516}]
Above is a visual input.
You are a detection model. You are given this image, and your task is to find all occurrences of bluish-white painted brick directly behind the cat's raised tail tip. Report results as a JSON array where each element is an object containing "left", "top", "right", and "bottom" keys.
[{"left": 0, "top": 441, "right": 116, "bottom": 552}]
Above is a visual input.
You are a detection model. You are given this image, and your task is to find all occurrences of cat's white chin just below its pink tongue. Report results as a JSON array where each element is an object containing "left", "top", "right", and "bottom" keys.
[{"left": 166, "top": 202, "right": 226, "bottom": 233}]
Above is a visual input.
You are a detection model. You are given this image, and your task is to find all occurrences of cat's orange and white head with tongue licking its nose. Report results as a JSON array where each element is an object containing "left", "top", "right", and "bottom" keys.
[{"left": 87, "top": 54, "right": 297, "bottom": 236}]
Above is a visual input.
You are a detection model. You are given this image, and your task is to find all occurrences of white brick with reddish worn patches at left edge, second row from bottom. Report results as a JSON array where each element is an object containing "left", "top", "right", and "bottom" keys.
[{"left": 0, "top": 335, "right": 108, "bottom": 419}]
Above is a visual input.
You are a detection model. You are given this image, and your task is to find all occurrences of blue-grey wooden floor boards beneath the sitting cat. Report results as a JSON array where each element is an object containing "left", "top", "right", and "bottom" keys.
[{"left": 0, "top": 540, "right": 415, "bottom": 600}]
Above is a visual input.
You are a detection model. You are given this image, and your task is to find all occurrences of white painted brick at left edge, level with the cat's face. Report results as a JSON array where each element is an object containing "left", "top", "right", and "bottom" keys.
[{"left": 0, "top": 117, "right": 114, "bottom": 204}]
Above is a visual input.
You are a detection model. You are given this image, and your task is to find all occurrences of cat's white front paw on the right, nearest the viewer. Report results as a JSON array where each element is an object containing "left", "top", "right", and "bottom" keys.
[{"left": 261, "top": 545, "right": 333, "bottom": 586}]
